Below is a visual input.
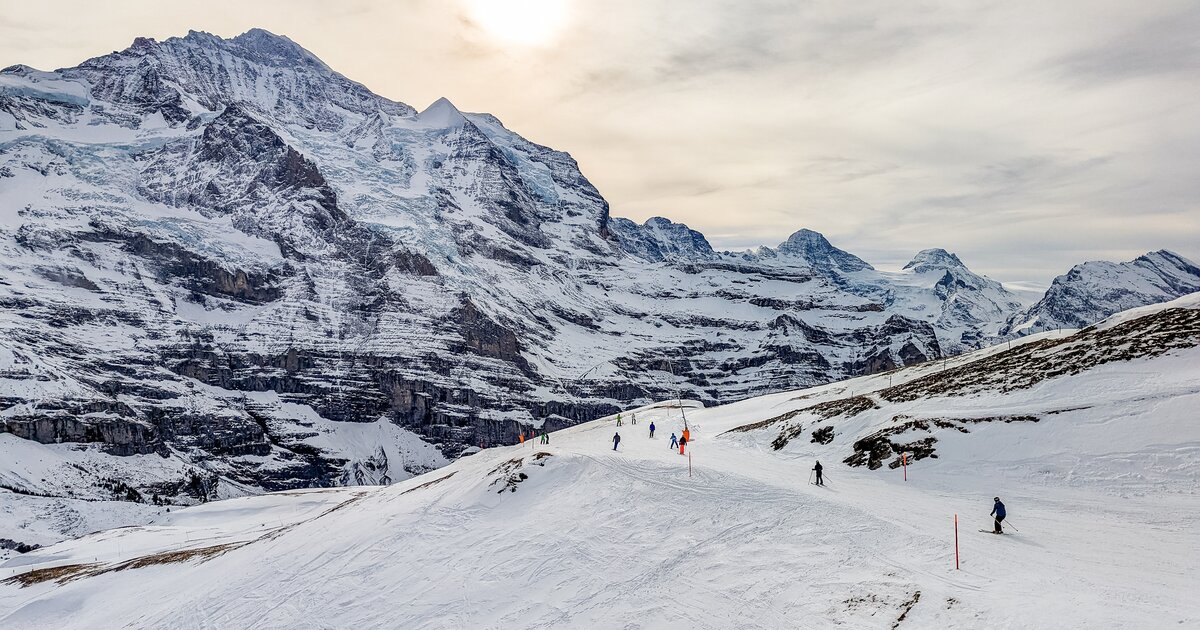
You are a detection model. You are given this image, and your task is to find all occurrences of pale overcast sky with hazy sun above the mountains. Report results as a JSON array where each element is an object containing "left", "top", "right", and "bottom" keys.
[{"left": 0, "top": 0, "right": 1200, "bottom": 283}]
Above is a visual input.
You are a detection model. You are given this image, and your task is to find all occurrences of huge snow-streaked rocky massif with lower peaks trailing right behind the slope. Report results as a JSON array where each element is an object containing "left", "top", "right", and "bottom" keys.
[{"left": 0, "top": 29, "right": 1195, "bottom": 511}]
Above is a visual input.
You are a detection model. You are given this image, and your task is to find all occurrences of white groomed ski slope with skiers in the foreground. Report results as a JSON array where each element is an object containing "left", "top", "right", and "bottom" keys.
[{"left": 0, "top": 295, "right": 1200, "bottom": 629}]
